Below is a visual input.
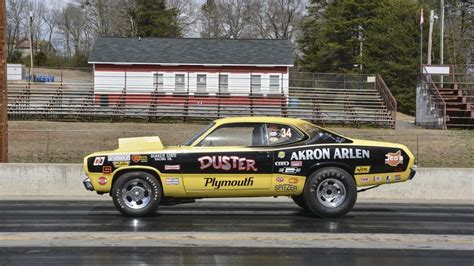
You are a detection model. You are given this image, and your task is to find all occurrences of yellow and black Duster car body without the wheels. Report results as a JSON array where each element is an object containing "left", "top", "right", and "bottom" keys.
[{"left": 84, "top": 117, "right": 415, "bottom": 217}]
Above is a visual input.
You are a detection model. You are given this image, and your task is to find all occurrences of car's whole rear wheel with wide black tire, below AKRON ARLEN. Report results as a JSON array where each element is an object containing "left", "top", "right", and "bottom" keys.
[{"left": 303, "top": 167, "right": 357, "bottom": 218}]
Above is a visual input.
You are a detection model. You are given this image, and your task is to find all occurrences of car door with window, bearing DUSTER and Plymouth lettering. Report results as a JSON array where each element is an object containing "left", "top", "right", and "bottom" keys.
[{"left": 181, "top": 123, "right": 273, "bottom": 197}]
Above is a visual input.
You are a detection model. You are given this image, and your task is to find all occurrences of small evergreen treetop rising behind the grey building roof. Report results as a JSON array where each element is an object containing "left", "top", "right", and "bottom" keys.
[{"left": 133, "top": 0, "right": 183, "bottom": 37}]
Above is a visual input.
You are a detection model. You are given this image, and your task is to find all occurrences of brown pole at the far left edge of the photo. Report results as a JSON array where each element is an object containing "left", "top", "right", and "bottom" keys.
[{"left": 0, "top": 0, "right": 8, "bottom": 163}]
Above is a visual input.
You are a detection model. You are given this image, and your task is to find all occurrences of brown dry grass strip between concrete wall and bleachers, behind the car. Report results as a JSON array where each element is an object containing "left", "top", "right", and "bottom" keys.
[{"left": 8, "top": 128, "right": 474, "bottom": 167}]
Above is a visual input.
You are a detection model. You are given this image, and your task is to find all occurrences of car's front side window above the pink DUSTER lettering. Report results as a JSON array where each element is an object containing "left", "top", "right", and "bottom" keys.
[{"left": 198, "top": 124, "right": 266, "bottom": 147}]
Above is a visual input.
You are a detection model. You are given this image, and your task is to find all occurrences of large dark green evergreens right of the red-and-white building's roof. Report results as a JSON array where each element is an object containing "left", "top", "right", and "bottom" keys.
[{"left": 298, "top": 0, "right": 437, "bottom": 113}]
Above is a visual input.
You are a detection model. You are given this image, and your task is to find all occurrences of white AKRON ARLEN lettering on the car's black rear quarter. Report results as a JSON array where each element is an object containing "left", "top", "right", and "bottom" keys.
[{"left": 290, "top": 148, "right": 370, "bottom": 161}]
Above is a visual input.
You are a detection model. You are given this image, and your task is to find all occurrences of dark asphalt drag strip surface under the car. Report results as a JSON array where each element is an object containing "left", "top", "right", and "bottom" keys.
[{"left": 0, "top": 200, "right": 474, "bottom": 265}]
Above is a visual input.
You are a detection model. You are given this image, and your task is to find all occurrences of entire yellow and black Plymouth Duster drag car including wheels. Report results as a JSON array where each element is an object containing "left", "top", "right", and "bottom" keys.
[{"left": 84, "top": 117, "right": 416, "bottom": 217}]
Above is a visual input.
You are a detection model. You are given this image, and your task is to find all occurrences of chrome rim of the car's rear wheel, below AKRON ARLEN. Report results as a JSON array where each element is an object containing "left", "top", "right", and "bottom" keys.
[{"left": 316, "top": 178, "right": 346, "bottom": 208}]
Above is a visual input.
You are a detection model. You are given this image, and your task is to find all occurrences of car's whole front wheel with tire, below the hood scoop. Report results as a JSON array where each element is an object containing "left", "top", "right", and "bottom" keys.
[{"left": 110, "top": 171, "right": 163, "bottom": 217}]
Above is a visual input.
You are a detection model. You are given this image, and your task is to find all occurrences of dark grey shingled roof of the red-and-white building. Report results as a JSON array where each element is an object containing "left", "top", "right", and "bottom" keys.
[{"left": 89, "top": 38, "right": 293, "bottom": 66}]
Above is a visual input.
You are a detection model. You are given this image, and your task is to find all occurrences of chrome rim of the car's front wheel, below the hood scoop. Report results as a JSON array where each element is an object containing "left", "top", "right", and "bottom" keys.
[{"left": 122, "top": 178, "right": 152, "bottom": 210}]
